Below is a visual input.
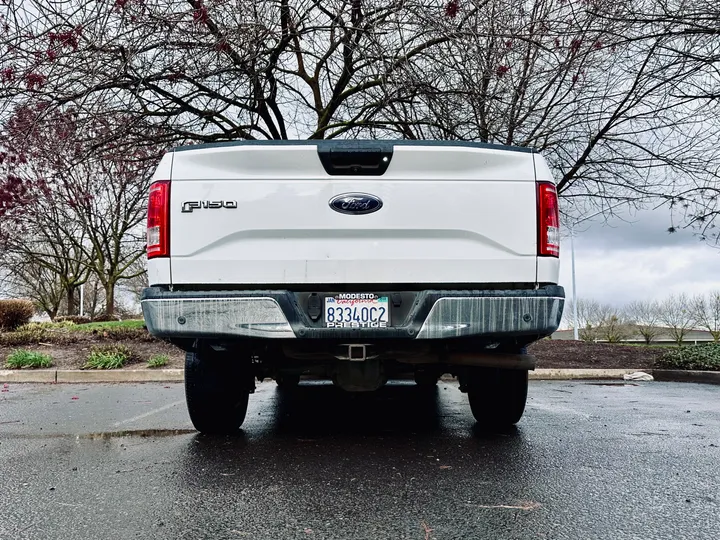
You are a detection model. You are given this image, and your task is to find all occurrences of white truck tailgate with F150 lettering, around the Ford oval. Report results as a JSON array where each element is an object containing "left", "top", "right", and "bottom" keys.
[{"left": 170, "top": 142, "right": 537, "bottom": 286}]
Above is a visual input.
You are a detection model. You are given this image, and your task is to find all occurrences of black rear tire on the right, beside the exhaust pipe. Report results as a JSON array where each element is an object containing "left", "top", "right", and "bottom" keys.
[{"left": 467, "top": 368, "right": 528, "bottom": 427}]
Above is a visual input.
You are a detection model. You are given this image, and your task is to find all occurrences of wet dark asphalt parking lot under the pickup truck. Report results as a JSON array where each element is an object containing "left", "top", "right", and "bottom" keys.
[{"left": 0, "top": 381, "right": 720, "bottom": 540}]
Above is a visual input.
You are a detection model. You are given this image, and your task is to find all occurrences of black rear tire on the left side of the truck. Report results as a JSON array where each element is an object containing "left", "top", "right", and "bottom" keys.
[{"left": 185, "top": 349, "right": 252, "bottom": 435}]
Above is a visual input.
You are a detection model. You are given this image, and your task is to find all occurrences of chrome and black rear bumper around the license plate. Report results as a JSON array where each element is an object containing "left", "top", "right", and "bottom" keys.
[{"left": 142, "top": 286, "right": 565, "bottom": 340}]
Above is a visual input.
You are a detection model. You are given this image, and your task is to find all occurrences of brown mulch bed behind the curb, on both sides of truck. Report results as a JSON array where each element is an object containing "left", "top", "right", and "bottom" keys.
[{"left": 0, "top": 333, "right": 665, "bottom": 369}]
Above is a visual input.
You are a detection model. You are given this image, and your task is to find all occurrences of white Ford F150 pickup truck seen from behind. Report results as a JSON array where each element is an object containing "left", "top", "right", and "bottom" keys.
[{"left": 142, "top": 140, "right": 564, "bottom": 433}]
